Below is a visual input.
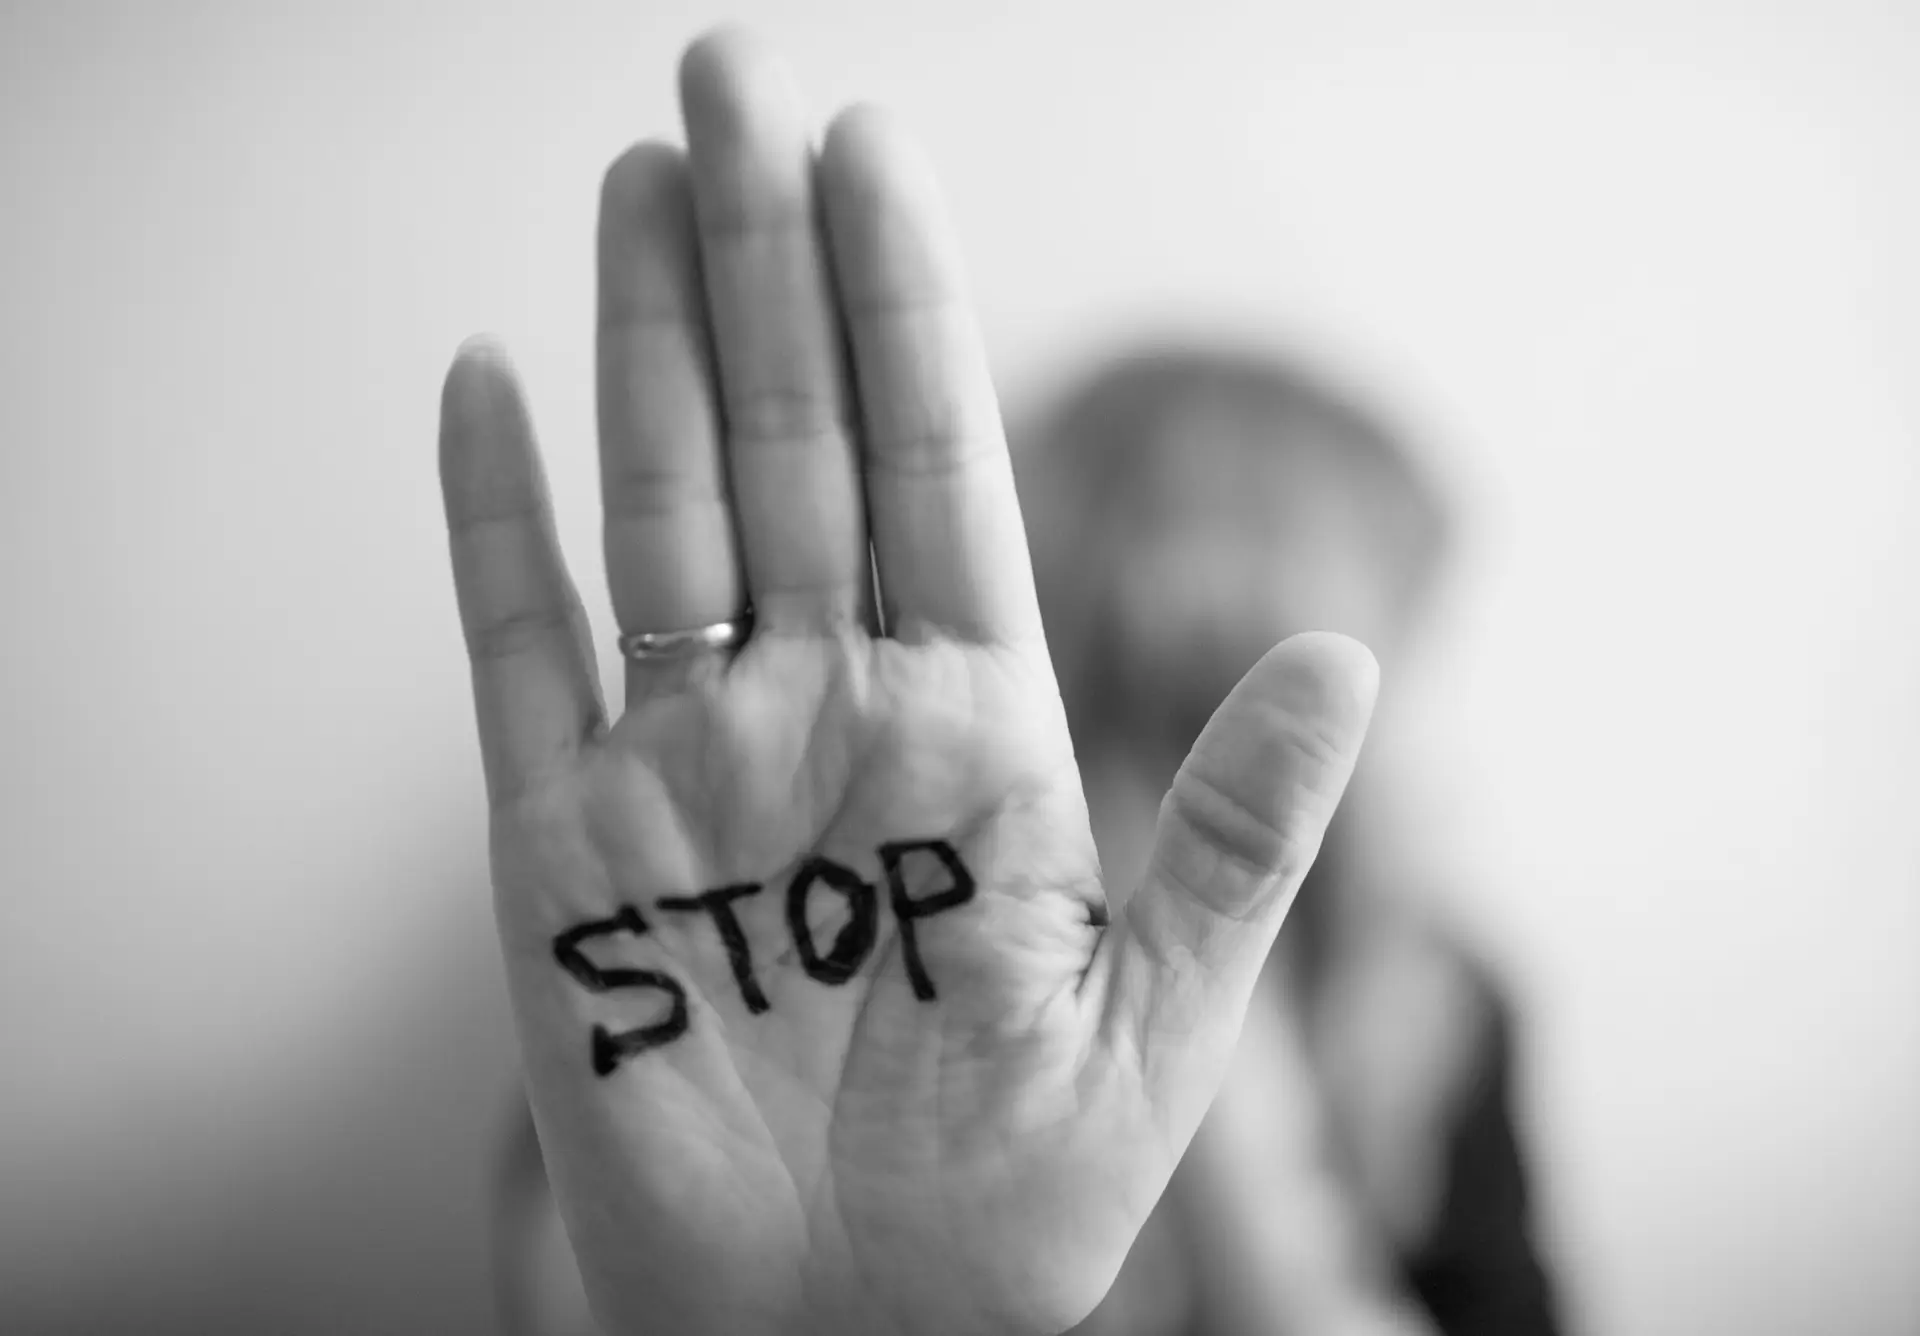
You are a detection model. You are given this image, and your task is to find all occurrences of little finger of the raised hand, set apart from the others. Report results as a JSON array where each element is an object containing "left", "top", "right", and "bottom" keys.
[{"left": 440, "top": 340, "right": 605, "bottom": 804}]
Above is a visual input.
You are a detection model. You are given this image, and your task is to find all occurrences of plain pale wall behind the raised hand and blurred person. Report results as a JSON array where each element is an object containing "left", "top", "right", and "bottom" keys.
[{"left": 0, "top": 0, "right": 1920, "bottom": 1336}]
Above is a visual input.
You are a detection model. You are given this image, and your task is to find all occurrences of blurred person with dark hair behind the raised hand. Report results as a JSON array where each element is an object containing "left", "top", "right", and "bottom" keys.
[{"left": 1016, "top": 344, "right": 1557, "bottom": 1336}]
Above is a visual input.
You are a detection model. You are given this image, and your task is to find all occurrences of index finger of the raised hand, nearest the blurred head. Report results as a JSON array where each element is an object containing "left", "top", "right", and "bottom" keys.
[{"left": 820, "top": 107, "right": 1041, "bottom": 641}]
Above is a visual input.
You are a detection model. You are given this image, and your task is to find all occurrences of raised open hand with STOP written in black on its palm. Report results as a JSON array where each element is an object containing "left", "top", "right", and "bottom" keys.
[{"left": 440, "top": 33, "right": 1375, "bottom": 1336}]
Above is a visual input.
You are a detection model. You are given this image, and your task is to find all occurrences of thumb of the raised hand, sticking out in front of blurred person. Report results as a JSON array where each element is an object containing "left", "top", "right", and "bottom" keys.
[{"left": 1106, "top": 632, "right": 1379, "bottom": 1133}]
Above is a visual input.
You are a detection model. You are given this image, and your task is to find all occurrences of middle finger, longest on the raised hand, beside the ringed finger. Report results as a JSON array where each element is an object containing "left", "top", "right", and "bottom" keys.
[{"left": 680, "top": 33, "right": 872, "bottom": 630}]
